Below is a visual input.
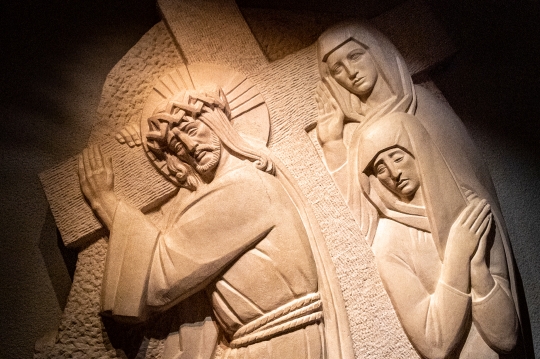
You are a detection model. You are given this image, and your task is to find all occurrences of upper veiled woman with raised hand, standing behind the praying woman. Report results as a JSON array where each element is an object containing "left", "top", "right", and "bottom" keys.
[{"left": 316, "top": 21, "right": 534, "bottom": 358}]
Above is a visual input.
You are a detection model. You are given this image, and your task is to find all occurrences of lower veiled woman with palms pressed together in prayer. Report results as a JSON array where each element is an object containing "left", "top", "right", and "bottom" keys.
[{"left": 355, "top": 112, "right": 523, "bottom": 359}]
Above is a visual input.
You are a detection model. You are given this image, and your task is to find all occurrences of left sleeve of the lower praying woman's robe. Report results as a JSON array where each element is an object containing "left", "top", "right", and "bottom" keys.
[{"left": 375, "top": 221, "right": 471, "bottom": 358}]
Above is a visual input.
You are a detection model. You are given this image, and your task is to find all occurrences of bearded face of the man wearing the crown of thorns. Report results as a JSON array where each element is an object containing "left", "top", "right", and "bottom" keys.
[{"left": 172, "top": 116, "right": 221, "bottom": 178}]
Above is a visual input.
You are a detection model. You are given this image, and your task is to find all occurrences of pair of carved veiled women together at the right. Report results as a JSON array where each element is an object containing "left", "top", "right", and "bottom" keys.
[{"left": 316, "top": 22, "right": 526, "bottom": 358}]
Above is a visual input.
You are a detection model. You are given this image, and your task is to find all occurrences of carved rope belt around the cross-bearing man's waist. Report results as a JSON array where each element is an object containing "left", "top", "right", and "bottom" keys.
[{"left": 229, "top": 293, "right": 323, "bottom": 348}]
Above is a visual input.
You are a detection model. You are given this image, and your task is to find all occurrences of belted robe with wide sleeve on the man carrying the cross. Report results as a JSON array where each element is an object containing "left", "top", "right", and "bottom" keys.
[{"left": 102, "top": 162, "right": 350, "bottom": 359}]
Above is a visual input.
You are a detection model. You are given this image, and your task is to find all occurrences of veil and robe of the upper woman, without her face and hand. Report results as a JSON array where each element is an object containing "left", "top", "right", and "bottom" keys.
[{"left": 317, "top": 21, "right": 534, "bottom": 358}]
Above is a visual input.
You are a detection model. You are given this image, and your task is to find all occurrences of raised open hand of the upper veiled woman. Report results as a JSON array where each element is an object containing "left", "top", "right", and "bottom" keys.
[{"left": 315, "top": 82, "right": 344, "bottom": 145}]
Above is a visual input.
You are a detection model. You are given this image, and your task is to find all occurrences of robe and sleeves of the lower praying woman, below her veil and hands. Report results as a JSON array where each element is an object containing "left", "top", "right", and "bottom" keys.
[{"left": 372, "top": 218, "right": 519, "bottom": 359}]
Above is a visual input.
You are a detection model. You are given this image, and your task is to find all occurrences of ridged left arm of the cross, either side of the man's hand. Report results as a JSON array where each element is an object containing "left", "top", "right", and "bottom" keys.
[{"left": 40, "top": 138, "right": 177, "bottom": 247}]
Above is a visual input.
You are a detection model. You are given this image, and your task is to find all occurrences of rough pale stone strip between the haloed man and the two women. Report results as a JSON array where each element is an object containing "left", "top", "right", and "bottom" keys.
[{"left": 253, "top": 46, "right": 417, "bottom": 358}]
